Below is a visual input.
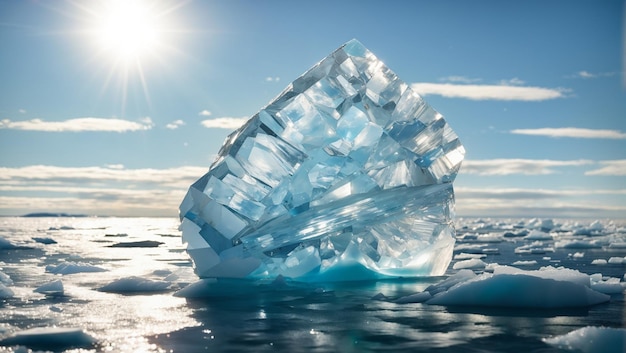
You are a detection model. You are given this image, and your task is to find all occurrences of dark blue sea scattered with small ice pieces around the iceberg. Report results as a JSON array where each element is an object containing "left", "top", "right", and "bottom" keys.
[{"left": 0, "top": 217, "right": 626, "bottom": 352}]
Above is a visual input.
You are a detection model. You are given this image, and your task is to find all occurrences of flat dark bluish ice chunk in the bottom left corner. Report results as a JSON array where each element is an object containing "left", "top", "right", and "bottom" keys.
[{"left": 0, "top": 327, "right": 97, "bottom": 351}]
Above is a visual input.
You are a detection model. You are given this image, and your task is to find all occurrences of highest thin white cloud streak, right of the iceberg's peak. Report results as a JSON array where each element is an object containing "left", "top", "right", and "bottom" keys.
[{"left": 411, "top": 82, "right": 569, "bottom": 101}]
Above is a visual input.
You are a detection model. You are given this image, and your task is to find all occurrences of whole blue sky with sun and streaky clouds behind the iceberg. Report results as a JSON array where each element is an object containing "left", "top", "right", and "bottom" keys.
[{"left": 0, "top": 0, "right": 626, "bottom": 218}]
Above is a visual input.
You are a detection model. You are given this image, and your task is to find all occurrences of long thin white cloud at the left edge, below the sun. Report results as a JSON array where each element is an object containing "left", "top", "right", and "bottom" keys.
[{"left": 0, "top": 117, "right": 154, "bottom": 132}]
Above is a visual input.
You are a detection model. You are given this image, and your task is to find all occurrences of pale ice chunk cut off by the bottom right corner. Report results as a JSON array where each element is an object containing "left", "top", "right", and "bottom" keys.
[{"left": 543, "top": 326, "right": 626, "bottom": 353}]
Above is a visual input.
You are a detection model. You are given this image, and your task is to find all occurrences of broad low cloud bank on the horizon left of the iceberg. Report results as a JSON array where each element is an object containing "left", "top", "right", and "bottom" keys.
[{"left": 0, "top": 164, "right": 208, "bottom": 216}]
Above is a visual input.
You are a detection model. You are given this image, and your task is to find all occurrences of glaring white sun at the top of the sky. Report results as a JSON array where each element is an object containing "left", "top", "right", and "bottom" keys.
[{"left": 68, "top": 0, "right": 184, "bottom": 111}]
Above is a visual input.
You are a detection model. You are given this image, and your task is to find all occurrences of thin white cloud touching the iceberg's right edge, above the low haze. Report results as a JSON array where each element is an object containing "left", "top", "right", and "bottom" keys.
[{"left": 462, "top": 158, "right": 594, "bottom": 175}]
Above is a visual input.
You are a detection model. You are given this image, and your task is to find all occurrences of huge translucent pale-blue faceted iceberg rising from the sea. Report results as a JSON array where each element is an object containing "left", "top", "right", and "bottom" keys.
[{"left": 180, "top": 40, "right": 465, "bottom": 281}]
